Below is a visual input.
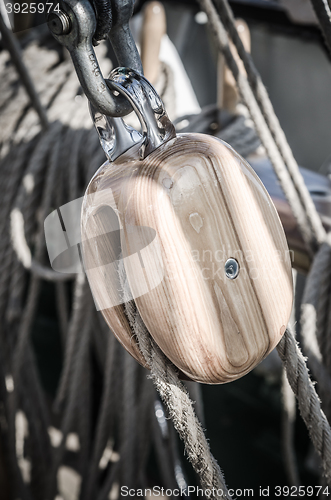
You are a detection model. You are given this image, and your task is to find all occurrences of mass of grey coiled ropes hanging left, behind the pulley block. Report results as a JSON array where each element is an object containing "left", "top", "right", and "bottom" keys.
[{"left": 0, "top": 27, "right": 192, "bottom": 500}]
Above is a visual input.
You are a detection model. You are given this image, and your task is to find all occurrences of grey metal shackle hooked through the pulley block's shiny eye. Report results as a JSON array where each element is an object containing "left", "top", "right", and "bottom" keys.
[{"left": 47, "top": 0, "right": 142, "bottom": 117}]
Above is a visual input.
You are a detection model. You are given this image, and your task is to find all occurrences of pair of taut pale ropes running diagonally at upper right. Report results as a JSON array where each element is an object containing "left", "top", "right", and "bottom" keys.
[{"left": 199, "top": 0, "right": 325, "bottom": 256}]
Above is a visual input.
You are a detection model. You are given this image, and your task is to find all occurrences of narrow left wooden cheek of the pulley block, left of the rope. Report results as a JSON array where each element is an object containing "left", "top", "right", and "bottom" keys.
[{"left": 81, "top": 148, "right": 146, "bottom": 366}]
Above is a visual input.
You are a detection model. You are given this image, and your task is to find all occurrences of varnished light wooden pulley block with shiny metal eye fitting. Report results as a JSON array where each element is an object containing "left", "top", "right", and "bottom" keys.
[{"left": 81, "top": 69, "right": 292, "bottom": 384}]
